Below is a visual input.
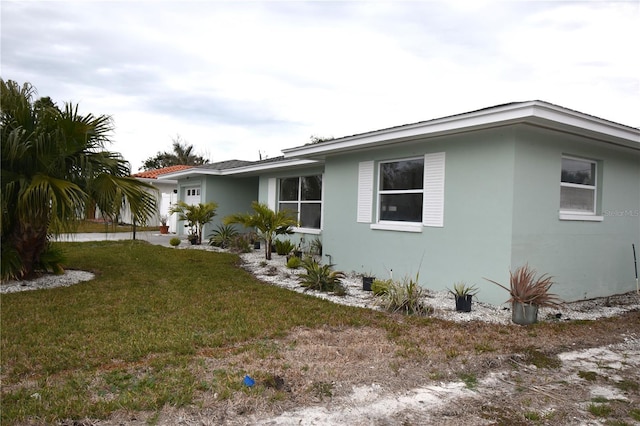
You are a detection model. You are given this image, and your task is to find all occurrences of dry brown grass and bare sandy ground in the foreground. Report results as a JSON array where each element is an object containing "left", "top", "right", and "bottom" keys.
[{"left": 97, "top": 312, "right": 640, "bottom": 426}]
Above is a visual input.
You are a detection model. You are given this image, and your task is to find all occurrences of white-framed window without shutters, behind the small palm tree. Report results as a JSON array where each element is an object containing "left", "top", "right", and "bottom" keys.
[{"left": 278, "top": 175, "right": 322, "bottom": 229}]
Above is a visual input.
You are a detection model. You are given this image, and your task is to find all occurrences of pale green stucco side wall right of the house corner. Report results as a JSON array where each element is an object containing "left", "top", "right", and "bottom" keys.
[{"left": 512, "top": 127, "right": 640, "bottom": 301}]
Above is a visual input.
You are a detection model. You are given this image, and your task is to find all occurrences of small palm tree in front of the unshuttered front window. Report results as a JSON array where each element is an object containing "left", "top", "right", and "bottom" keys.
[{"left": 224, "top": 201, "right": 298, "bottom": 260}]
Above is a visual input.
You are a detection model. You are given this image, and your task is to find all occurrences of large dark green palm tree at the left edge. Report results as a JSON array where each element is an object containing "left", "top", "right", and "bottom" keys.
[{"left": 0, "top": 79, "right": 156, "bottom": 279}]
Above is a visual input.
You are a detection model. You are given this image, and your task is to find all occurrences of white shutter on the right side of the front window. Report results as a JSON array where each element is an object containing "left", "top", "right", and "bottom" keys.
[{"left": 422, "top": 152, "right": 445, "bottom": 228}]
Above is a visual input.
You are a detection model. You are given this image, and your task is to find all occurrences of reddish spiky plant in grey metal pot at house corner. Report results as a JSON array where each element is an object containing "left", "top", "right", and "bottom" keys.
[{"left": 485, "top": 265, "right": 564, "bottom": 325}]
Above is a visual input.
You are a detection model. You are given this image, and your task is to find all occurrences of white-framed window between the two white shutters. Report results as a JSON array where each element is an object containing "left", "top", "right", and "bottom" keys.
[{"left": 378, "top": 158, "right": 424, "bottom": 222}]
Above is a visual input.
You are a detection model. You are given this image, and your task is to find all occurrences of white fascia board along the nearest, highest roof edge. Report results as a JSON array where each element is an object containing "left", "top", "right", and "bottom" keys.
[{"left": 282, "top": 101, "right": 640, "bottom": 158}]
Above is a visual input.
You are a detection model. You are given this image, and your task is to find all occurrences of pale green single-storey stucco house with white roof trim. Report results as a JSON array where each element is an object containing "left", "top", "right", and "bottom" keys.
[{"left": 156, "top": 101, "right": 640, "bottom": 303}]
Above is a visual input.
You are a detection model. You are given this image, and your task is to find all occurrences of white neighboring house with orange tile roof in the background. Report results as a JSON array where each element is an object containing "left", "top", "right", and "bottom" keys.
[{"left": 127, "top": 165, "right": 193, "bottom": 232}]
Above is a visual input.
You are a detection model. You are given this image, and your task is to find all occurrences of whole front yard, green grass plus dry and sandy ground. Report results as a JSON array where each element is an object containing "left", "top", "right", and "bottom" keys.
[{"left": 1, "top": 241, "right": 640, "bottom": 425}]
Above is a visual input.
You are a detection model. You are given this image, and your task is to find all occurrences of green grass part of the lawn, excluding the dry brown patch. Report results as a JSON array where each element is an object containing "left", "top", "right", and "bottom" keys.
[{"left": 0, "top": 241, "right": 383, "bottom": 425}]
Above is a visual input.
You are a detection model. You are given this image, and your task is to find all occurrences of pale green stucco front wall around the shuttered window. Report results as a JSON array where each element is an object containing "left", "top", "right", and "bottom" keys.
[{"left": 323, "top": 129, "right": 514, "bottom": 303}]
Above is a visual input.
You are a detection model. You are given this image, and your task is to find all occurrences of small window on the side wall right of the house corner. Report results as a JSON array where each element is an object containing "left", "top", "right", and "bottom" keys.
[{"left": 560, "top": 157, "right": 597, "bottom": 215}]
